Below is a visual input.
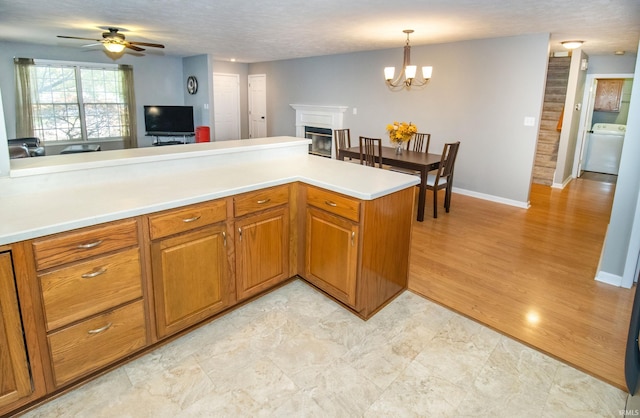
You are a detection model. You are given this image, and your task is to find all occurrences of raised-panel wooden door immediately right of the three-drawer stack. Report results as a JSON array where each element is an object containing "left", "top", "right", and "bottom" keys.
[{"left": 151, "top": 223, "right": 232, "bottom": 337}]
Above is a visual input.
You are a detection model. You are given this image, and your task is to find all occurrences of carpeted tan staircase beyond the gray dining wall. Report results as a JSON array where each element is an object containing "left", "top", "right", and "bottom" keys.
[{"left": 533, "top": 57, "right": 571, "bottom": 186}]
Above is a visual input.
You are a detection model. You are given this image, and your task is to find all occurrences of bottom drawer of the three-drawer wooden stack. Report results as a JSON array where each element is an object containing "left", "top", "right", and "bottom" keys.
[{"left": 47, "top": 300, "right": 146, "bottom": 387}]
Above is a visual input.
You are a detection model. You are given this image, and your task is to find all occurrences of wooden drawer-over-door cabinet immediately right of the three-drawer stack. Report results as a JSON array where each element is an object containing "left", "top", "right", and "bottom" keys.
[{"left": 148, "top": 200, "right": 235, "bottom": 338}]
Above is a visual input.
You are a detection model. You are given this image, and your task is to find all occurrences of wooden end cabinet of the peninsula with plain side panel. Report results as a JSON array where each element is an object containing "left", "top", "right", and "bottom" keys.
[{"left": 304, "top": 186, "right": 414, "bottom": 319}]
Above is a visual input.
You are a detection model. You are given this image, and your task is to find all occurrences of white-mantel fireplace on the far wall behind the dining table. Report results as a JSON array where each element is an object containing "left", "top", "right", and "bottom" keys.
[{"left": 291, "top": 104, "right": 347, "bottom": 158}]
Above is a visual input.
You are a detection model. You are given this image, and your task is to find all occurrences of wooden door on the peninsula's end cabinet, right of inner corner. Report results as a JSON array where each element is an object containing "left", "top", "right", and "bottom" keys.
[{"left": 305, "top": 207, "right": 358, "bottom": 310}]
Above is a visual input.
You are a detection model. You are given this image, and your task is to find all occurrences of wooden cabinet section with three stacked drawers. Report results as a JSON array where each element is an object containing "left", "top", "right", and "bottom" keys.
[{"left": 32, "top": 219, "right": 148, "bottom": 388}]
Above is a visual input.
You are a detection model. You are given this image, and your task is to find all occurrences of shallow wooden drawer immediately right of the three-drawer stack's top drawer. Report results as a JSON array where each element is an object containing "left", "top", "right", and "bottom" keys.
[{"left": 149, "top": 200, "right": 227, "bottom": 239}]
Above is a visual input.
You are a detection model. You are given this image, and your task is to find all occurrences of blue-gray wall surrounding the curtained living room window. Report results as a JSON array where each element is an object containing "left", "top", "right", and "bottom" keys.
[{"left": 0, "top": 41, "right": 186, "bottom": 146}]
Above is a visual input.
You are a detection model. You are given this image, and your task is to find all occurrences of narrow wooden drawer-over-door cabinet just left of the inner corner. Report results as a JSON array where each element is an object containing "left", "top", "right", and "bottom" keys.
[{"left": 234, "top": 185, "right": 289, "bottom": 299}]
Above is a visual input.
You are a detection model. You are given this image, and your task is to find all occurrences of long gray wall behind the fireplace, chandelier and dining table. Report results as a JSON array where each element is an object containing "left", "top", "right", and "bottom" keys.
[{"left": 249, "top": 34, "right": 549, "bottom": 206}]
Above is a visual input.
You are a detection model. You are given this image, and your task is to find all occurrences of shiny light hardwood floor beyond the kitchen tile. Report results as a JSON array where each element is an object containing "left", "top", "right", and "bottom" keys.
[{"left": 409, "top": 179, "right": 634, "bottom": 390}]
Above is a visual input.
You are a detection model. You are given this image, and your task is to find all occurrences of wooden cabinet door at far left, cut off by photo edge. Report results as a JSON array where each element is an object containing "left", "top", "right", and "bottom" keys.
[{"left": 0, "top": 252, "right": 32, "bottom": 409}]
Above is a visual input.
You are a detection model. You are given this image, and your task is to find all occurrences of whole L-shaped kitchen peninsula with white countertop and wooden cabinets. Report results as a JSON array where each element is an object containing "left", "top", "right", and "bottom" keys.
[{"left": 0, "top": 137, "right": 418, "bottom": 415}]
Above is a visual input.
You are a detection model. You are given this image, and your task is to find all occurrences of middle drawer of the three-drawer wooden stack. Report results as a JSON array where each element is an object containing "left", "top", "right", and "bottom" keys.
[{"left": 39, "top": 248, "right": 142, "bottom": 331}]
